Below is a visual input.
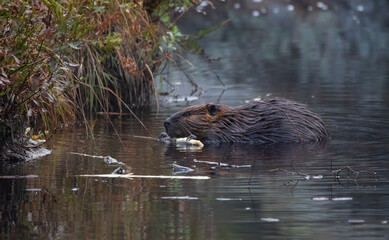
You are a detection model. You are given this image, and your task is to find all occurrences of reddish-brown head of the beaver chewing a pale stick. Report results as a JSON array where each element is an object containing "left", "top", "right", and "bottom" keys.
[{"left": 164, "top": 103, "right": 229, "bottom": 140}]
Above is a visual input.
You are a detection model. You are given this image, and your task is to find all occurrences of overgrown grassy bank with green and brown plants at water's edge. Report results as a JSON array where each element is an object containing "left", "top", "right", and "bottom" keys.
[{"left": 0, "top": 0, "right": 203, "bottom": 159}]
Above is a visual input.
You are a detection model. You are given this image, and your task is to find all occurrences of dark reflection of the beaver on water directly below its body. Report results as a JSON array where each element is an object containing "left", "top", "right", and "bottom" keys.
[{"left": 165, "top": 142, "right": 330, "bottom": 173}]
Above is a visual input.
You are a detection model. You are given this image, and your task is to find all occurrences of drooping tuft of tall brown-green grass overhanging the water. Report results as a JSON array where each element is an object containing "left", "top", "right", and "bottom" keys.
[{"left": 77, "top": 0, "right": 163, "bottom": 111}]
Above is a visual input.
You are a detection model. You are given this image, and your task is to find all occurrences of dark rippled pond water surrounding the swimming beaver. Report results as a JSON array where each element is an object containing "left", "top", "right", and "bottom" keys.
[{"left": 0, "top": 0, "right": 389, "bottom": 239}]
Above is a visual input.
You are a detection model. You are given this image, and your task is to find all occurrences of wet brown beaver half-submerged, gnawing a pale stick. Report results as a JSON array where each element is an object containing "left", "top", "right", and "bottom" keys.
[{"left": 164, "top": 98, "right": 329, "bottom": 144}]
